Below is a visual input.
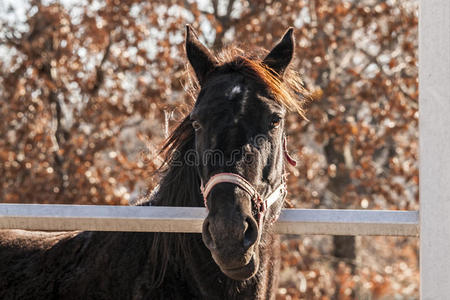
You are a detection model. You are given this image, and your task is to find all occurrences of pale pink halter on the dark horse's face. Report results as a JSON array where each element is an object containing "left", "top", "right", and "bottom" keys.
[{"left": 200, "top": 137, "right": 297, "bottom": 225}]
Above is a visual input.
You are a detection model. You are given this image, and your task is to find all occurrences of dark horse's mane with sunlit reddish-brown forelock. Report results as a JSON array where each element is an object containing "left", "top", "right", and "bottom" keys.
[{"left": 142, "top": 47, "right": 309, "bottom": 288}]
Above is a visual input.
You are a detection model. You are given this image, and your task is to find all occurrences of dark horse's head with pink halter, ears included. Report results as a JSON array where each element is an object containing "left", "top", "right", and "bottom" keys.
[{"left": 186, "top": 26, "right": 300, "bottom": 280}]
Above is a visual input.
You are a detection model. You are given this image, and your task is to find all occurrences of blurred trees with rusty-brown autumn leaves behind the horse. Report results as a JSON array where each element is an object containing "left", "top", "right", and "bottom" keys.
[{"left": 0, "top": 0, "right": 418, "bottom": 299}]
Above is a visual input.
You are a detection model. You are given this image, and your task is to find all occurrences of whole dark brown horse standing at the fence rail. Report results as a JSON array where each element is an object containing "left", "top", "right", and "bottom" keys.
[{"left": 0, "top": 25, "right": 307, "bottom": 300}]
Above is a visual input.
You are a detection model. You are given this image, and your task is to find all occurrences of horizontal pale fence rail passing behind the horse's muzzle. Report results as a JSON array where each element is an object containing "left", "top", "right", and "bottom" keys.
[{"left": 0, "top": 204, "right": 419, "bottom": 236}]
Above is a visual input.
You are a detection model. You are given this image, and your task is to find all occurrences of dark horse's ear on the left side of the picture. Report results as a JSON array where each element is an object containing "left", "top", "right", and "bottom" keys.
[{"left": 186, "top": 25, "right": 217, "bottom": 85}]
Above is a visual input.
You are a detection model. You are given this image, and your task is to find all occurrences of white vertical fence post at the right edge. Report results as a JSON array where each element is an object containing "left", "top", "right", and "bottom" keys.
[{"left": 419, "top": 0, "right": 450, "bottom": 300}]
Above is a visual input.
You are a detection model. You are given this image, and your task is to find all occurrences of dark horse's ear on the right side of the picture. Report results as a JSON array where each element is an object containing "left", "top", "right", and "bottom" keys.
[{"left": 263, "top": 27, "right": 294, "bottom": 75}]
